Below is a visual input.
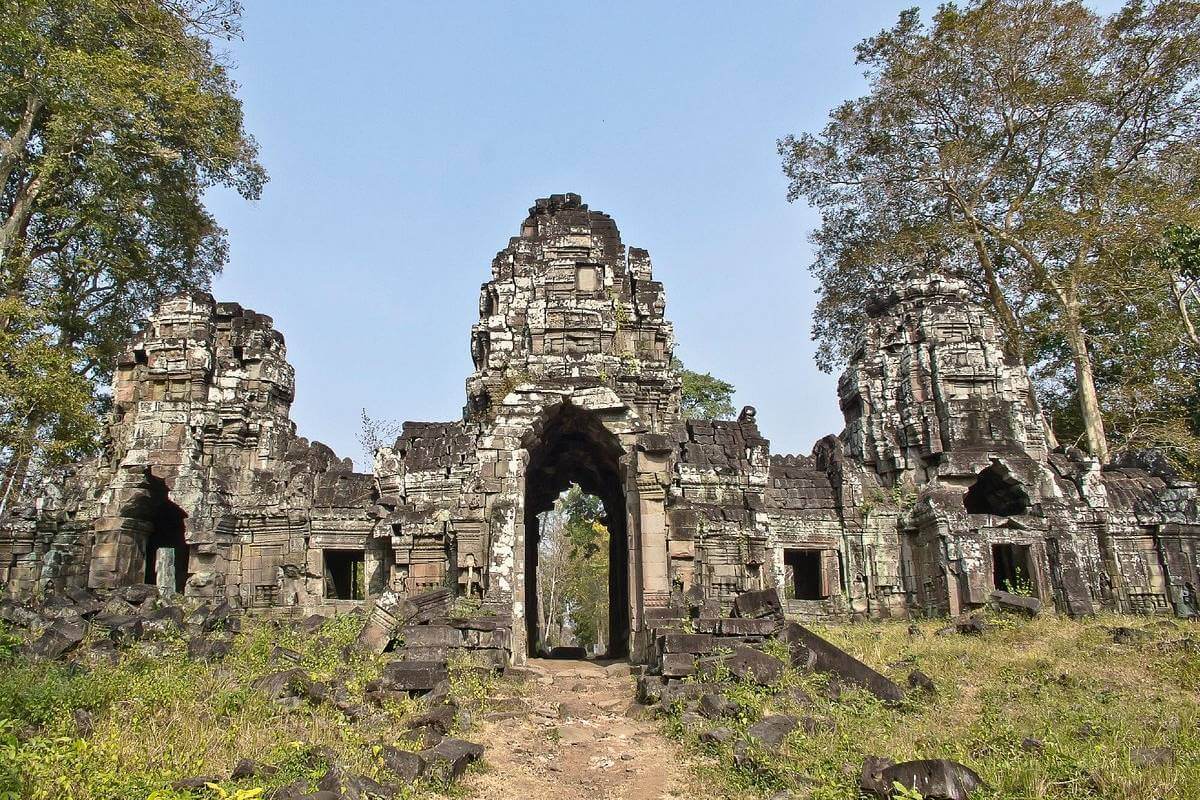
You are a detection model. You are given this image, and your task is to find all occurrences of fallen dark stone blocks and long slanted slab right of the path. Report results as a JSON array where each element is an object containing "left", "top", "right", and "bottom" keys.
[{"left": 637, "top": 589, "right": 982, "bottom": 800}]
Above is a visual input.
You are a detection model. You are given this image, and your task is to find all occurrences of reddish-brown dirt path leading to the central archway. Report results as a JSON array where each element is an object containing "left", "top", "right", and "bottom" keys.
[{"left": 466, "top": 660, "right": 689, "bottom": 800}]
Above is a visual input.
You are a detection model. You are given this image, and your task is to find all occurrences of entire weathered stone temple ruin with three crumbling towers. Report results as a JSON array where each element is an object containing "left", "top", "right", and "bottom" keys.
[{"left": 0, "top": 194, "right": 1200, "bottom": 661}]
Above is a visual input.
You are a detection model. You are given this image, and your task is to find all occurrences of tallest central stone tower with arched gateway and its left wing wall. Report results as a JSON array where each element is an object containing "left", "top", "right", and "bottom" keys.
[{"left": 376, "top": 194, "right": 680, "bottom": 655}]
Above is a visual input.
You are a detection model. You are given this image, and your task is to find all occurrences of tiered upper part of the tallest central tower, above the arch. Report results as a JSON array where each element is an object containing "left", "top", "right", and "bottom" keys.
[{"left": 466, "top": 194, "right": 679, "bottom": 431}]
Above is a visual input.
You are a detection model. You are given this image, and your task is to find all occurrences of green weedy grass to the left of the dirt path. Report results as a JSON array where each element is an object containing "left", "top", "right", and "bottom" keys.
[{"left": 0, "top": 615, "right": 498, "bottom": 800}]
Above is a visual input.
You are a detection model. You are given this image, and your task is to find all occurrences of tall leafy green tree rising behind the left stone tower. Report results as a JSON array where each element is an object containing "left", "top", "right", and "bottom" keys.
[{"left": 0, "top": 0, "right": 266, "bottom": 487}]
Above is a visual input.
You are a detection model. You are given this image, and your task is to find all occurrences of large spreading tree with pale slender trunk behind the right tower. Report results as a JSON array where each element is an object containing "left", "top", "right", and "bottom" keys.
[{"left": 780, "top": 0, "right": 1200, "bottom": 461}]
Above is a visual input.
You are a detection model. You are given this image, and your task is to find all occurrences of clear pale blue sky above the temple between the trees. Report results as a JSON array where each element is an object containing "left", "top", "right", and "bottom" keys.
[{"left": 210, "top": 0, "right": 993, "bottom": 467}]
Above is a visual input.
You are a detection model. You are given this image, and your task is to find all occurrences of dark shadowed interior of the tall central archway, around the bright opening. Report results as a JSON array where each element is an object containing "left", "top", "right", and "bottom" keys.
[{"left": 524, "top": 402, "right": 629, "bottom": 657}]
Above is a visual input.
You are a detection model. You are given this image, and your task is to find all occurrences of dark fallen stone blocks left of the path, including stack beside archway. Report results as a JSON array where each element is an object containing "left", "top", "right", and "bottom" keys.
[{"left": 0, "top": 585, "right": 496, "bottom": 800}]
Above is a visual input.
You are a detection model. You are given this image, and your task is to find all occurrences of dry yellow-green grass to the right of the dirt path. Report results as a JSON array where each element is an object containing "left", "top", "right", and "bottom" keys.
[{"left": 666, "top": 615, "right": 1200, "bottom": 800}]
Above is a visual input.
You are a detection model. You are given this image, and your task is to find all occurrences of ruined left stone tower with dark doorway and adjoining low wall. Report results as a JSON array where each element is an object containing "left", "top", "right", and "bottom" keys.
[{"left": 2, "top": 294, "right": 373, "bottom": 608}]
